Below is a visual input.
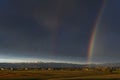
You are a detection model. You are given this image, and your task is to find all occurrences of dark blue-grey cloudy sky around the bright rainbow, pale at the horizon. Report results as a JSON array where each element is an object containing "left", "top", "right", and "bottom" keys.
[{"left": 0, "top": 0, "right": 120, "bottom": 63}]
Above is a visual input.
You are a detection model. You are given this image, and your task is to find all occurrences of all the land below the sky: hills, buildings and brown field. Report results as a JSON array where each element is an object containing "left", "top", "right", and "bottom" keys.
[{"left": 0, "top": 63, "right": 120, "bottom": 80}]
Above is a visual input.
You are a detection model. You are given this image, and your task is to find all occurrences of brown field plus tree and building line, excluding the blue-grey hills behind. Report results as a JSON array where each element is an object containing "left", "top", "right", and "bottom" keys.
[{"left": 0, "top": 67, "right": 120, "bottom": 80}]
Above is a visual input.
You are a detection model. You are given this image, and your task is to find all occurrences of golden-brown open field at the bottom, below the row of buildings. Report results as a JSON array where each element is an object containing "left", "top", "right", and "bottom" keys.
[{"left": 0, "top": 70, "right": 120, "bottom": 80}]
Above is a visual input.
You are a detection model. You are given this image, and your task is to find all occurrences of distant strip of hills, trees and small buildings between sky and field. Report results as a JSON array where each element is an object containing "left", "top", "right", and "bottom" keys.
[{"left": 0, "top": 62, "right": 120, "bottom": 72}]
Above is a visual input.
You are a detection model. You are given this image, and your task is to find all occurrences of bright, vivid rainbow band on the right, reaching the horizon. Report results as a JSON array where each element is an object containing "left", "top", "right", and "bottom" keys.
[{"left": 87, "top": 0, "right": 106, "bottom": 64}]
